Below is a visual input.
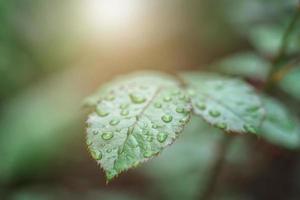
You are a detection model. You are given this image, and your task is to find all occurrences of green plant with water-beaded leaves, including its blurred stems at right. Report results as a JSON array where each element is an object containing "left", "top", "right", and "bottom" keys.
[{"left": 86, "top": 1, "right": 300, "bottom": 199}]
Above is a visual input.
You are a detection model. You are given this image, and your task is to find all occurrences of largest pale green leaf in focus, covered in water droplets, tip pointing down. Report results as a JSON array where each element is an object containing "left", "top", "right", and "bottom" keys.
[{"left": 87, "top": 74, "right": 191, "bottom": 180}]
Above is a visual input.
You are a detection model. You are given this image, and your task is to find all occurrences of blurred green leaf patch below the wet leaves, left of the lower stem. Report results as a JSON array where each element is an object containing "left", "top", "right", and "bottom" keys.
[{"left": 141, "top": 116, "right": 223, "bottom": 200}]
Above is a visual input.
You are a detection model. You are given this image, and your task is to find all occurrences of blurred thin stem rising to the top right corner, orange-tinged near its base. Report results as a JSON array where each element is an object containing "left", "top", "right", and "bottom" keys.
[{"left": 264, "top": 0, "right": 300, "bottom": 90}]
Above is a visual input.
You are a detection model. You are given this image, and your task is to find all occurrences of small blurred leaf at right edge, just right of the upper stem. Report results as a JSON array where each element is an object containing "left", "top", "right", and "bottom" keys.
[{"left": 279, "top": 66, "right": 300, "bottom": 100}]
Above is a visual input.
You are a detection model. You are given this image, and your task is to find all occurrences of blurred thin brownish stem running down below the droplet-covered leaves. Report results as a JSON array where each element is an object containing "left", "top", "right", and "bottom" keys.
[{"left": 199, "top": 133, "right": 232, "bottom": 200}]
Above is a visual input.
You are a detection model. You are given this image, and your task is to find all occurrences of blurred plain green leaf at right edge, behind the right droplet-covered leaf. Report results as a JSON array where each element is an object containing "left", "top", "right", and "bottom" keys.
[{"left": 260, "top": 96, "right": 300, "bottom": 149}]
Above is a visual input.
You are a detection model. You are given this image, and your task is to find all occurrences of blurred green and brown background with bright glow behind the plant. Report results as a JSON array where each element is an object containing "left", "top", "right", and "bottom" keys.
[{"left": 0, "top": 0, "right": 300, "bottom": 200}]
